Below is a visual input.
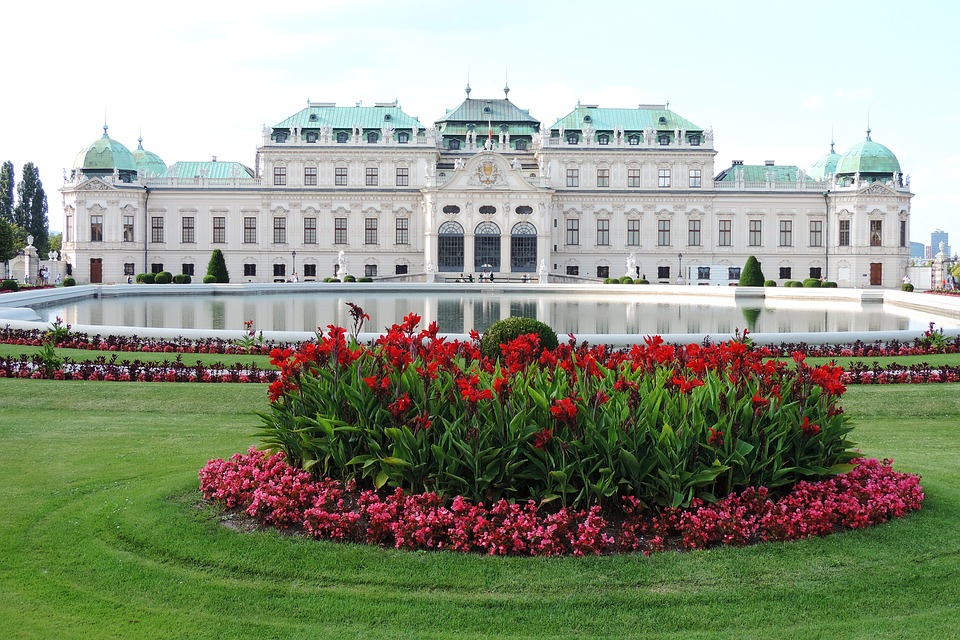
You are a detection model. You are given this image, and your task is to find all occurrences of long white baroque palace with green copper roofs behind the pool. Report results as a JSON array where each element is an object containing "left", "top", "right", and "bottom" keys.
[{"left": 61, "top": 87, "right": 913, "bottom": 287}]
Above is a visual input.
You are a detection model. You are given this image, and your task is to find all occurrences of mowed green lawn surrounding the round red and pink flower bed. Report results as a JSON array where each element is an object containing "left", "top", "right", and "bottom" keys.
[{"left": 0, "top": 379, "right": 960, "bottom": 639}]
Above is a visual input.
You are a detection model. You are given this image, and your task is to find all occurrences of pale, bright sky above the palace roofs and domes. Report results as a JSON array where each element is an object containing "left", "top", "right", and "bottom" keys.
[{"left": 0, "top": 0, "right": 960, "bottom": 252}]
